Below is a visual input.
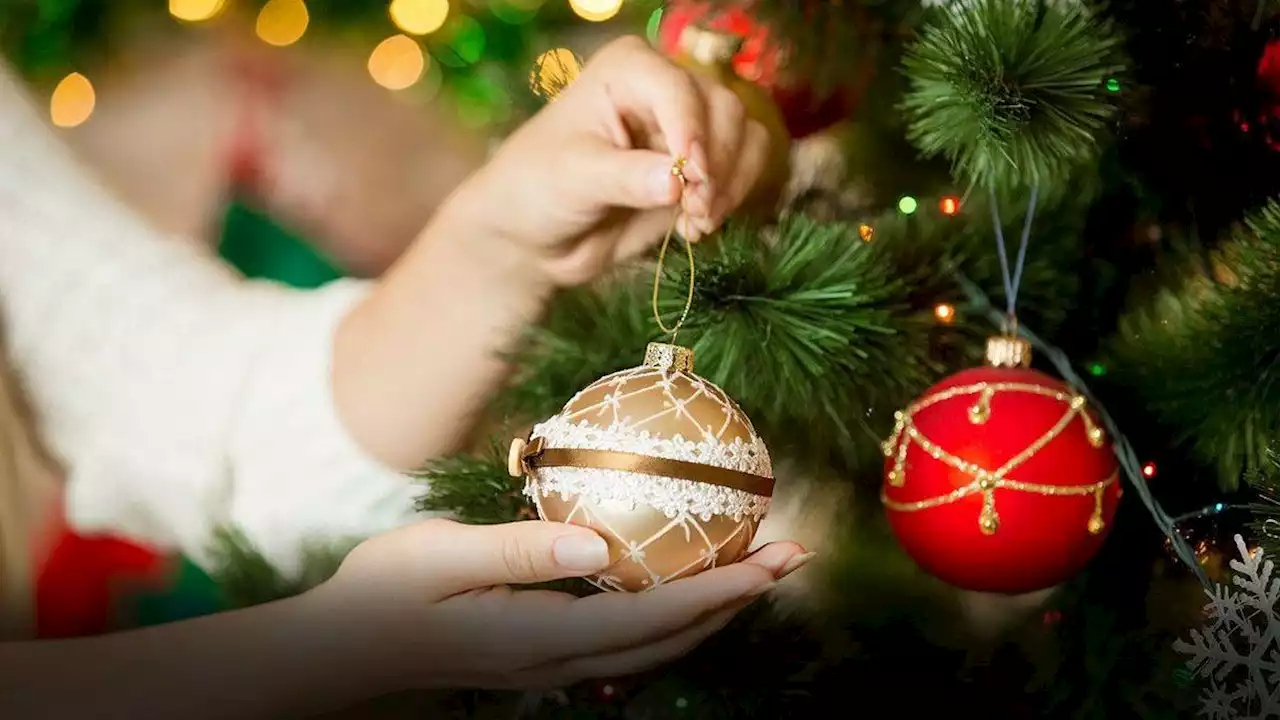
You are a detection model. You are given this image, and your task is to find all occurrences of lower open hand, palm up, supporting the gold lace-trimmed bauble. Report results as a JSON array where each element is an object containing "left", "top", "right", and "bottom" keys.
[{"left": 314, "top": 520, "right": 809, "bottom": 692}]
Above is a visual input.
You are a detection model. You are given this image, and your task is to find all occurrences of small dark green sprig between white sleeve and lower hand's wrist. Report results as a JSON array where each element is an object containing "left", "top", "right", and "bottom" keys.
[{"left": 211, "top": 520, "right": 356, "bottom": 609}]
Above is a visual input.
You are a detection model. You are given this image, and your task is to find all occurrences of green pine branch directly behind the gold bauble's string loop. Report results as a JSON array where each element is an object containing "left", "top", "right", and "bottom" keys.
[{"left": 497, "top": 215, "right": 940, "bottom": 473}]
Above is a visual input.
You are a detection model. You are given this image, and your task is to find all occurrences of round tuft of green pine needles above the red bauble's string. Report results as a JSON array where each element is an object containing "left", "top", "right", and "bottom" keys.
[{"left": 902, "top": 0, "right": 1123, "bottom": 188}]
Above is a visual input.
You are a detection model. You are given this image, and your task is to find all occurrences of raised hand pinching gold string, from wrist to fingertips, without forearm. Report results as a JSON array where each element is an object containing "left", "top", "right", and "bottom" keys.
[{"left": 435, "top": 32, "right": 769, "bottom": 286}]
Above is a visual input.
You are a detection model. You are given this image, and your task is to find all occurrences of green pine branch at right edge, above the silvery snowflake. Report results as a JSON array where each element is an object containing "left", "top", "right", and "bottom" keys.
[{"left": 1114, "top": 202, "right": 1280, "bottom": 489}]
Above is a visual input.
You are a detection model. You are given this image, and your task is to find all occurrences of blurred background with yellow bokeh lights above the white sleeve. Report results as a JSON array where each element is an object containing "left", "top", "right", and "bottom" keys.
[{"left": 0, "top": 0, "right": 658, "bottom": 286}]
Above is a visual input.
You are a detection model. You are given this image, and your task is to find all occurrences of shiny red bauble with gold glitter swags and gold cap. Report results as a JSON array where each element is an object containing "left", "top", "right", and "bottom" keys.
[{"left": 881, "top": 338, "right": 1120, "bottom": 594}]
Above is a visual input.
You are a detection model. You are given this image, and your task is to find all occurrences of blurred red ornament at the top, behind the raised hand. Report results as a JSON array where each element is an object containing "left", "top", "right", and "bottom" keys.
[{"left": 658, "top": 0, "right": 870, "bottom": 140}]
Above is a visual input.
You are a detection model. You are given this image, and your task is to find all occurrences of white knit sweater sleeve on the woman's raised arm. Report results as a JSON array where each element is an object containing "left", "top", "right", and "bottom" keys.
[{"left": 0, "top": 68, "right": 420, "bottom": 570}]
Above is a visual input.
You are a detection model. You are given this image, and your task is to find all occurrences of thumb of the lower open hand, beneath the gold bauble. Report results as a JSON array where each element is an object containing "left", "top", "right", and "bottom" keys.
[{"left": 421, "top": 520, "right": 609, "bottom": 597}]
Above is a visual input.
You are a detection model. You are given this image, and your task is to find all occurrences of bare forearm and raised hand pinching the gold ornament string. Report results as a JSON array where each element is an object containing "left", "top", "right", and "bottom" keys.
[{"left": 334, "top": 38, "right": 767, "bottom": 469}]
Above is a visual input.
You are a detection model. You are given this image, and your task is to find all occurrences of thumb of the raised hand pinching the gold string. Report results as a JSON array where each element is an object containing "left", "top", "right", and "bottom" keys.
[{"left": 579, "top": 146, "right": 682, "bottom": 210}]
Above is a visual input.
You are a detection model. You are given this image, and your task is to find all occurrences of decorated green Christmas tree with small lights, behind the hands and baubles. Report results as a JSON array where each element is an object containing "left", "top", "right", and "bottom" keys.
[{"left": 4, "top": 0, "right": 1280, "bottom": 719}]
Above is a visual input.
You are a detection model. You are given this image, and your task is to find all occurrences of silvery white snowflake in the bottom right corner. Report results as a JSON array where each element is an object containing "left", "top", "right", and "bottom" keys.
[{"left": 1174, "top": 536, "right": 1280, "bottom": 720}]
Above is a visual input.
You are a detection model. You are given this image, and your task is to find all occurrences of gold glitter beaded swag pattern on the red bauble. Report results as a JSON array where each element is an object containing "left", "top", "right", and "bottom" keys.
[{"left": 881, "top": 383, "right": 1120, "bottom": 536}]
